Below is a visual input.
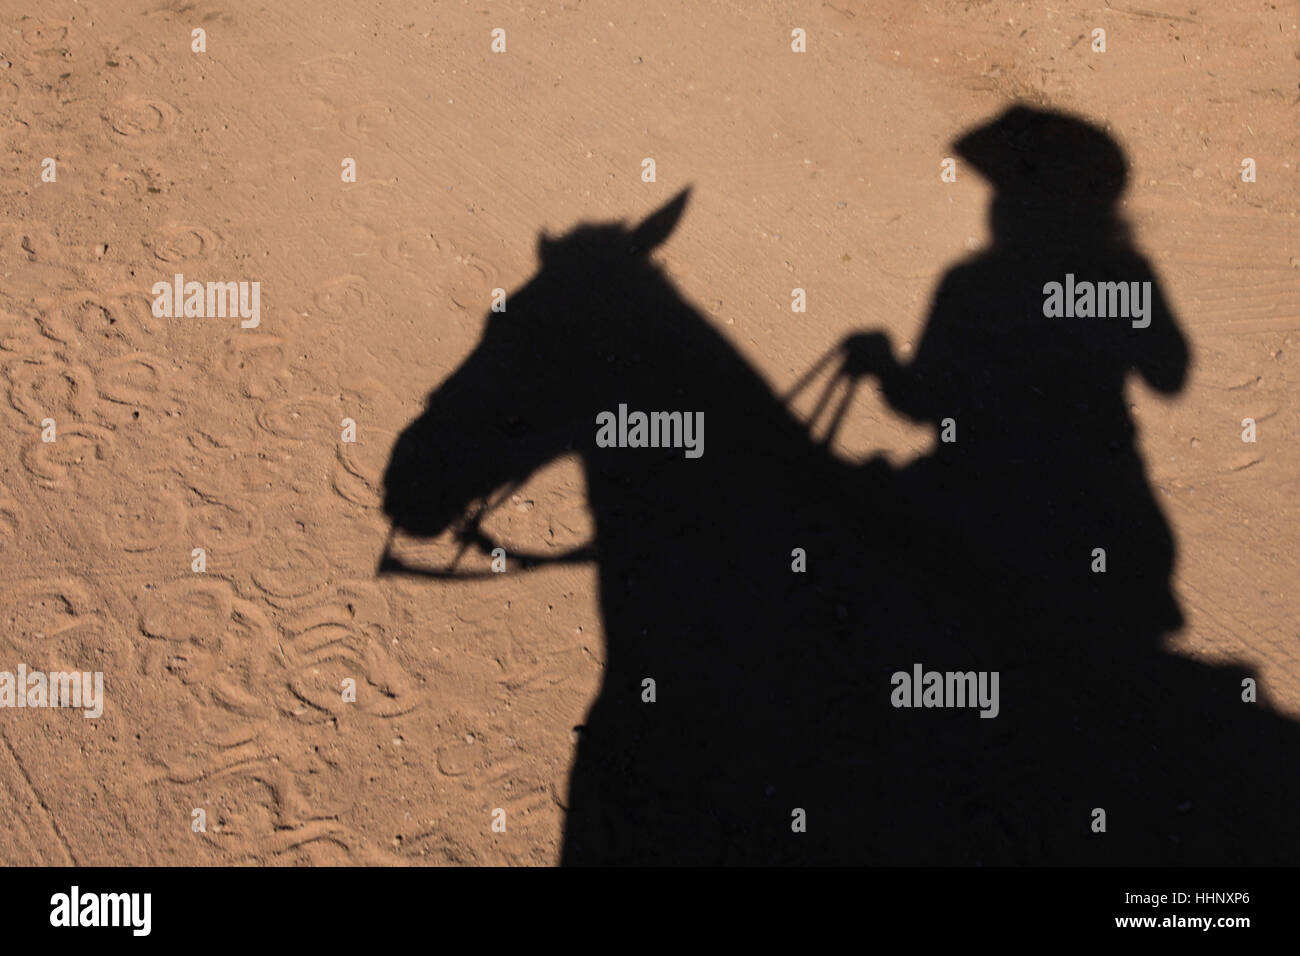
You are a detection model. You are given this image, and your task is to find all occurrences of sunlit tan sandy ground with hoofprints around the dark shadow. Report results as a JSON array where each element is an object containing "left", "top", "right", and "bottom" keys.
[{"left": 0, "top": 0, "right": 1300, "bottom": 865}]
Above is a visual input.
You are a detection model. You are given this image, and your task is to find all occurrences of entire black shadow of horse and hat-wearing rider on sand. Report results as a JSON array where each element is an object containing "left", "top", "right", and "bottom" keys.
[{"left": 381, "top": 107, "right": 1300, "bottom": 865}]
